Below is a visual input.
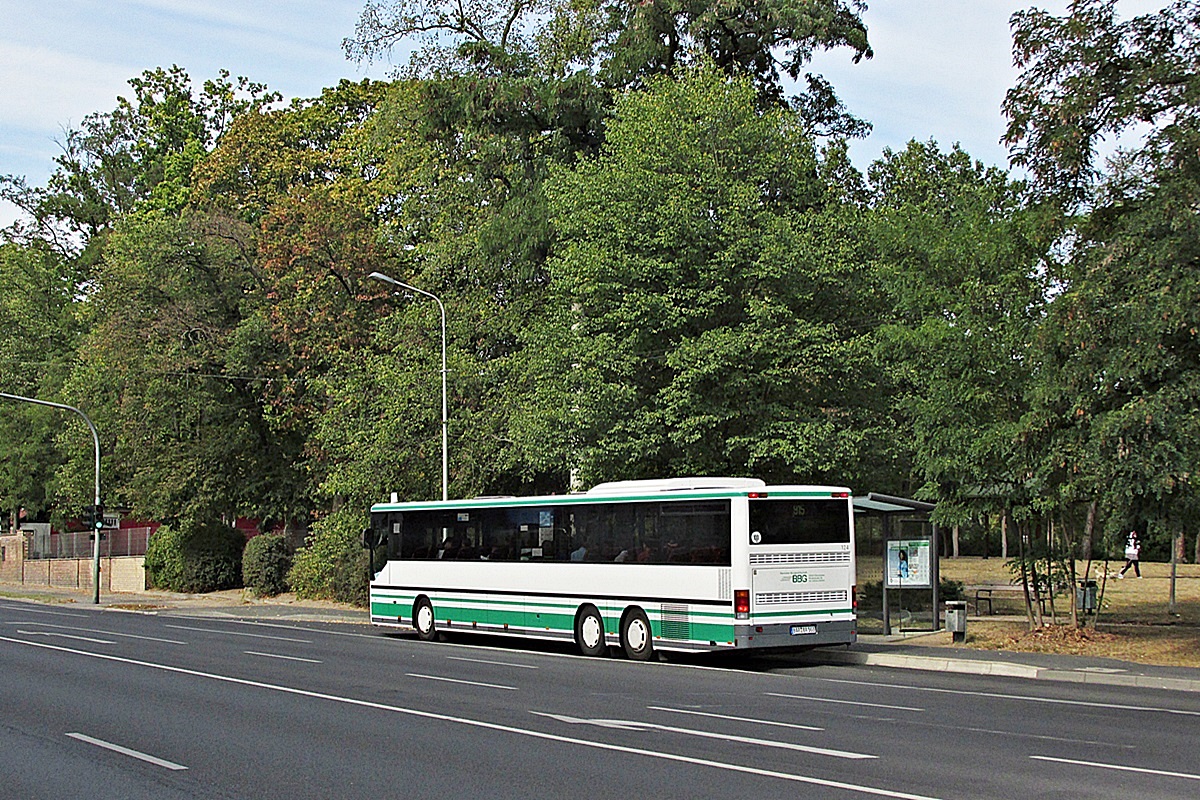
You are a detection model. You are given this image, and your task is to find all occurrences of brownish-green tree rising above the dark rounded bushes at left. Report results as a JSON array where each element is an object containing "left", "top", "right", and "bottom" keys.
[{"left": 65, "top": 211, "right": 308, "bottom": 523}]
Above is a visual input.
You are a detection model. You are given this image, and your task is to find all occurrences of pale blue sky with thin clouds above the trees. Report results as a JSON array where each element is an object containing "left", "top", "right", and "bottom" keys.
[{"left": 0, "top": 0, "right": 1164, "bottom": 225}]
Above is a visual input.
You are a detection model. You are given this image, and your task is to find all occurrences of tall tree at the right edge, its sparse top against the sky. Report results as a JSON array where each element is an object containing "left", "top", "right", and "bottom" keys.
[{"left": 1006, "top": 0, "right": 1200, "bottom": 563}]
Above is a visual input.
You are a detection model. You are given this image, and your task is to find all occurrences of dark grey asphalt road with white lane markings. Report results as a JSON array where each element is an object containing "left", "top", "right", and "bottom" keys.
[{"left": 0, "top": 600, "right": 1200, "bottom": 800}]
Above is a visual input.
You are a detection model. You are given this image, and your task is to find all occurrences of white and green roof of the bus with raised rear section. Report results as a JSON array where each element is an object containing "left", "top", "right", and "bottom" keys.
[{"left": 371, "top": 477, "right": 850, "bottom": 511}]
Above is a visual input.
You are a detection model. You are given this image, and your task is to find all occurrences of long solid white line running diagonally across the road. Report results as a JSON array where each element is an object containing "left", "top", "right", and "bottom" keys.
[{"left": 7, "top": 636, "right": 938, "bottom": 800}]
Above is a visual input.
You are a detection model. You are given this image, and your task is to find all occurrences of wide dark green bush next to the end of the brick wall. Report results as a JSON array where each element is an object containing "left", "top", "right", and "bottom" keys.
[{"left": 145, "top": 522, "right": 246, "bottom": 593}]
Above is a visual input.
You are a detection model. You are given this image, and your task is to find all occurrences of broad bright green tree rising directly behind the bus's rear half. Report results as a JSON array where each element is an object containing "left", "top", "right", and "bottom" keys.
[{"left": 540, "top": 68, "right": 878, "bottom": 481}]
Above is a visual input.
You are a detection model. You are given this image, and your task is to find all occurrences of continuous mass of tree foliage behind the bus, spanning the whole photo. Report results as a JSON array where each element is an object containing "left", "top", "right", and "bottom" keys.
[{"left": 9, "top": 0, "right": 1200, "bottom": 602}]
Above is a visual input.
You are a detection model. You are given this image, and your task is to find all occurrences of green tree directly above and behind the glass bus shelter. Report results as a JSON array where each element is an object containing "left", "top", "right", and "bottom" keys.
[{"left": 869, "top": 142, "right": 1056, "bottom": 624}]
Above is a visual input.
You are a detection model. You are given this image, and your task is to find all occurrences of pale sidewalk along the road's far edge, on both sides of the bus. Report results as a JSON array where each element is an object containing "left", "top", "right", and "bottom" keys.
[{"left": 7, "top": 584, "right": 1200, "bottom": 692}]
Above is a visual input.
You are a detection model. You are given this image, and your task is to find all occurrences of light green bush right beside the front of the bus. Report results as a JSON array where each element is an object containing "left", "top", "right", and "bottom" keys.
[{"left": 288, "top": 507, "right": 367, "bottom": 607}]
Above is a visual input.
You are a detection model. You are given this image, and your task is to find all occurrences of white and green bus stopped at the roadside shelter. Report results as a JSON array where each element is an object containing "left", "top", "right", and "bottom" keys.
[{"left": 366, "top": 479, "right": 856, "bottom": 660}]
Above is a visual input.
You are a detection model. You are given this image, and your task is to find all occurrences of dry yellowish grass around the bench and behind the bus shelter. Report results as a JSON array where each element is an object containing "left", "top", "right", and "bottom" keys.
[{"left": 859, "top": 557, "right": 1200, "bottom": 667}]
